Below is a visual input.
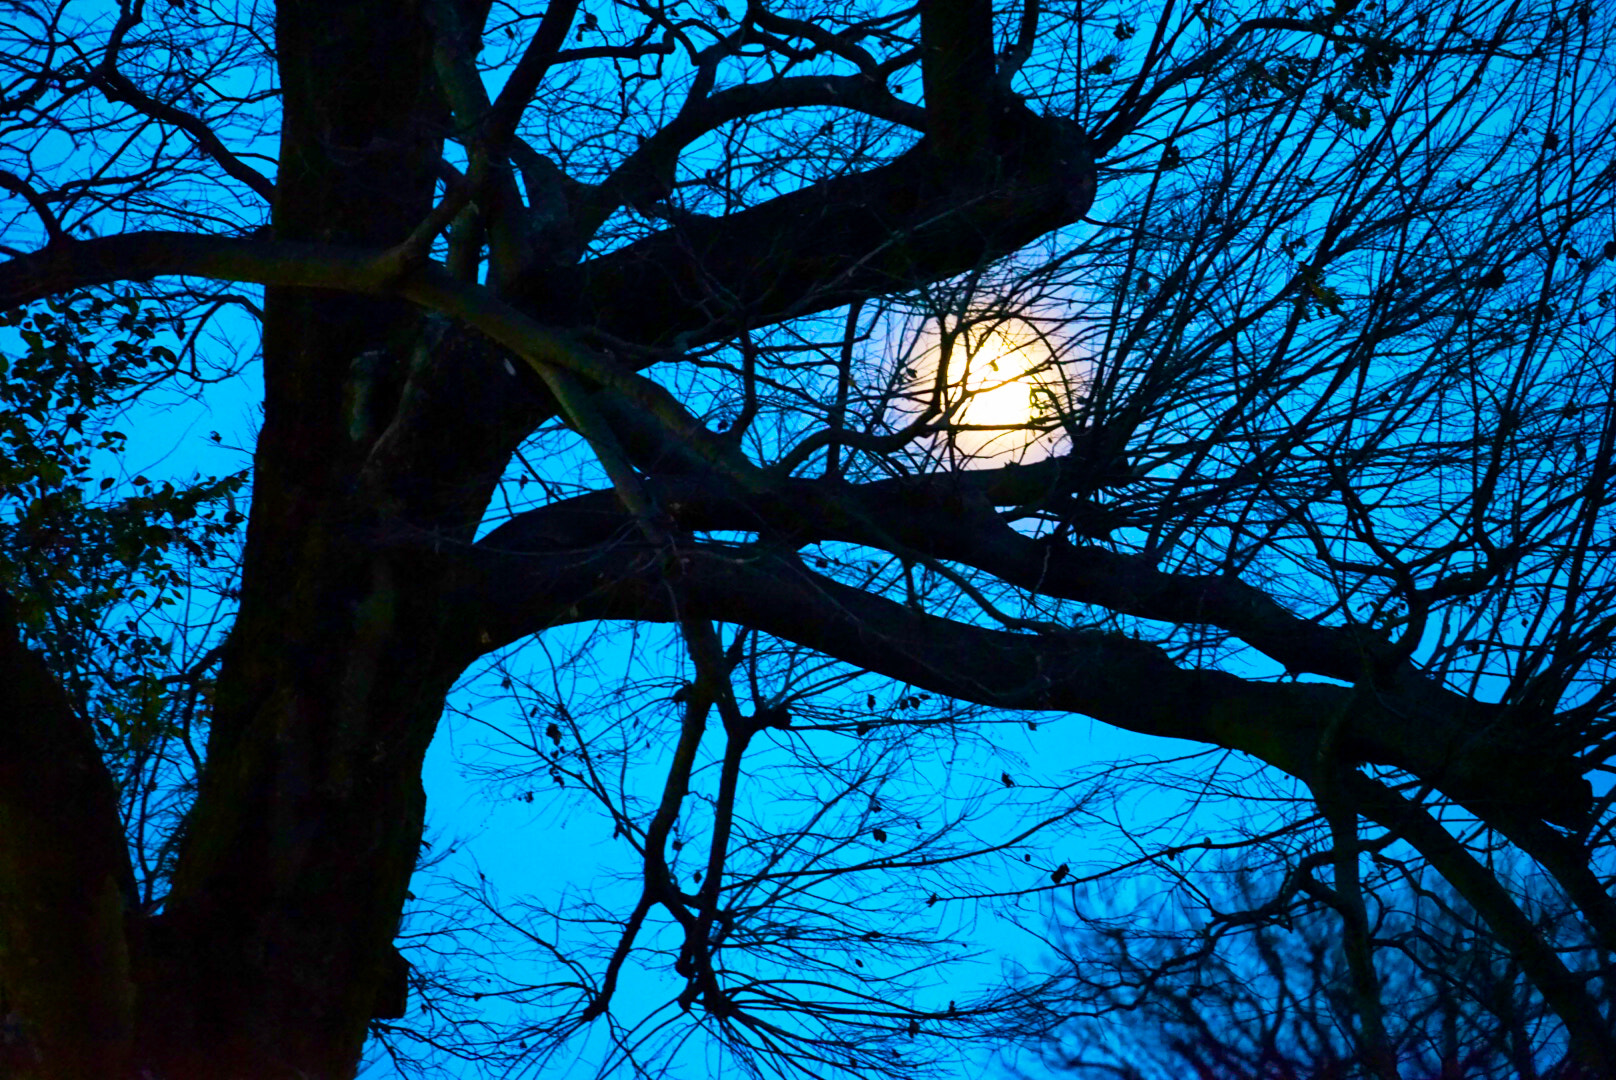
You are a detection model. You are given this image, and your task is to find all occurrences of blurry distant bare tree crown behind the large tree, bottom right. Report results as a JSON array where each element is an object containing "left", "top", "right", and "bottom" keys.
[{"left": 1012, "top": 827, "right": 1611, "bottom": 1080}]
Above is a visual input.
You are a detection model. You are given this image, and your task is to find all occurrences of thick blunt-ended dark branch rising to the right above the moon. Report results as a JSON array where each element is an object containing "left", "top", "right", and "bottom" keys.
[{"left": 511, "top": 105, "right": 1096, "bottom": 344}]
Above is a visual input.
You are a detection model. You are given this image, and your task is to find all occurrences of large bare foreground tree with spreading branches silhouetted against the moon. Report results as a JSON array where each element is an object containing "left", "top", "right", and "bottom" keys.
[{"left": 0, "top": 0, "right": 1616, "bottom": 1077}]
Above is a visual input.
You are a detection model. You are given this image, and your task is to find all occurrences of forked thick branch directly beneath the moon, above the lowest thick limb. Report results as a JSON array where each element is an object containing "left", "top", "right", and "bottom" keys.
[{"left": 491, "top": 468, "right": 1564, "bottom": 802}]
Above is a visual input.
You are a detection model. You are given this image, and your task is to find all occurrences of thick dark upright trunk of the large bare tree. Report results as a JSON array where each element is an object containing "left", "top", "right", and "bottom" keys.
[{"left": 136, "top": 0, "right": 461, "bottom": 1078}]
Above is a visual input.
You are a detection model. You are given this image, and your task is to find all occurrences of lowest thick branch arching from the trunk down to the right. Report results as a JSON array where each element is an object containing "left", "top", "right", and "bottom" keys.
[{"left": 451, "top": 533, "right": 1587, "bottom": 820}]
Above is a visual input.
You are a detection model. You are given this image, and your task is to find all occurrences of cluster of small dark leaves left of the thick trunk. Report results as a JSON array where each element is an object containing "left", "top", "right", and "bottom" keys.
[{"left": 0, "top": 293, "right": 246, "bottom": 785}]
